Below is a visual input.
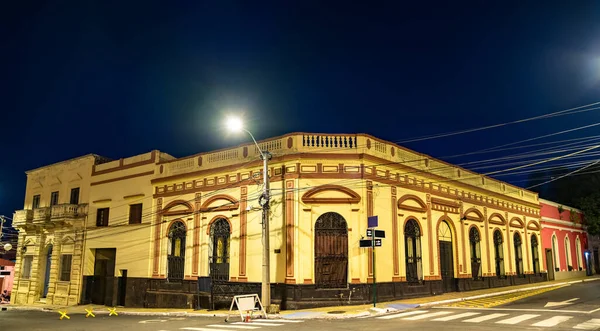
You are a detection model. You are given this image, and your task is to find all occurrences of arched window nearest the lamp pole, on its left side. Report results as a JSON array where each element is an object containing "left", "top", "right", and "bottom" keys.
[{"left": 209, "top": 218, "right": 231, "bottom": 281}]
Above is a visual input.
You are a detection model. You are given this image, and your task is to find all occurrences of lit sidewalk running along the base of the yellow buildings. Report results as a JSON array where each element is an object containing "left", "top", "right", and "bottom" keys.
[{"left": 5, "top": 277, "right": 600, "bottom": 319}]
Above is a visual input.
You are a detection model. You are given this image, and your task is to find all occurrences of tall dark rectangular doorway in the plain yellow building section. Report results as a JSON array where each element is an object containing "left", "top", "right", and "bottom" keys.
[{"left": 92, "top": 248, "right": 117, "bottom": 306}]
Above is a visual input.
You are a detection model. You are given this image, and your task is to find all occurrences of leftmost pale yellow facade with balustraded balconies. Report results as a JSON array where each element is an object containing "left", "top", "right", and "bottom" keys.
[{"left": 11, "top": 154, "right": 105, "bottom": 305}]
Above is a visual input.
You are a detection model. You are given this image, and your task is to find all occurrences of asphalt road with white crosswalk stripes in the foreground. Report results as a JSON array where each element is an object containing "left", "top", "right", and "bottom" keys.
[{"left": 0, "top": 281, "right": 600, "bottom": 331}]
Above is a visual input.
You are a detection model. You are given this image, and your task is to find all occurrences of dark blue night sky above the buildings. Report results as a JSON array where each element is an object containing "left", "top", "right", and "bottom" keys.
[{"left": 0, "top": 0, "right": 600, "bottom": 220}]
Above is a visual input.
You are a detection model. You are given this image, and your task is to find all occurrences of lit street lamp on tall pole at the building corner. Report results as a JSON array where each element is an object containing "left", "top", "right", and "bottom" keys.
[{"left": 226, "top": 117, "right": 271, "bottom": 307}]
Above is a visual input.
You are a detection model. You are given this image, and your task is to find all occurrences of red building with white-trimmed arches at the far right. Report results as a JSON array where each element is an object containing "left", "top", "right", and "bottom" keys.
[{"left": 540, "top": 199, "right": 589, "bottom": 280}]
